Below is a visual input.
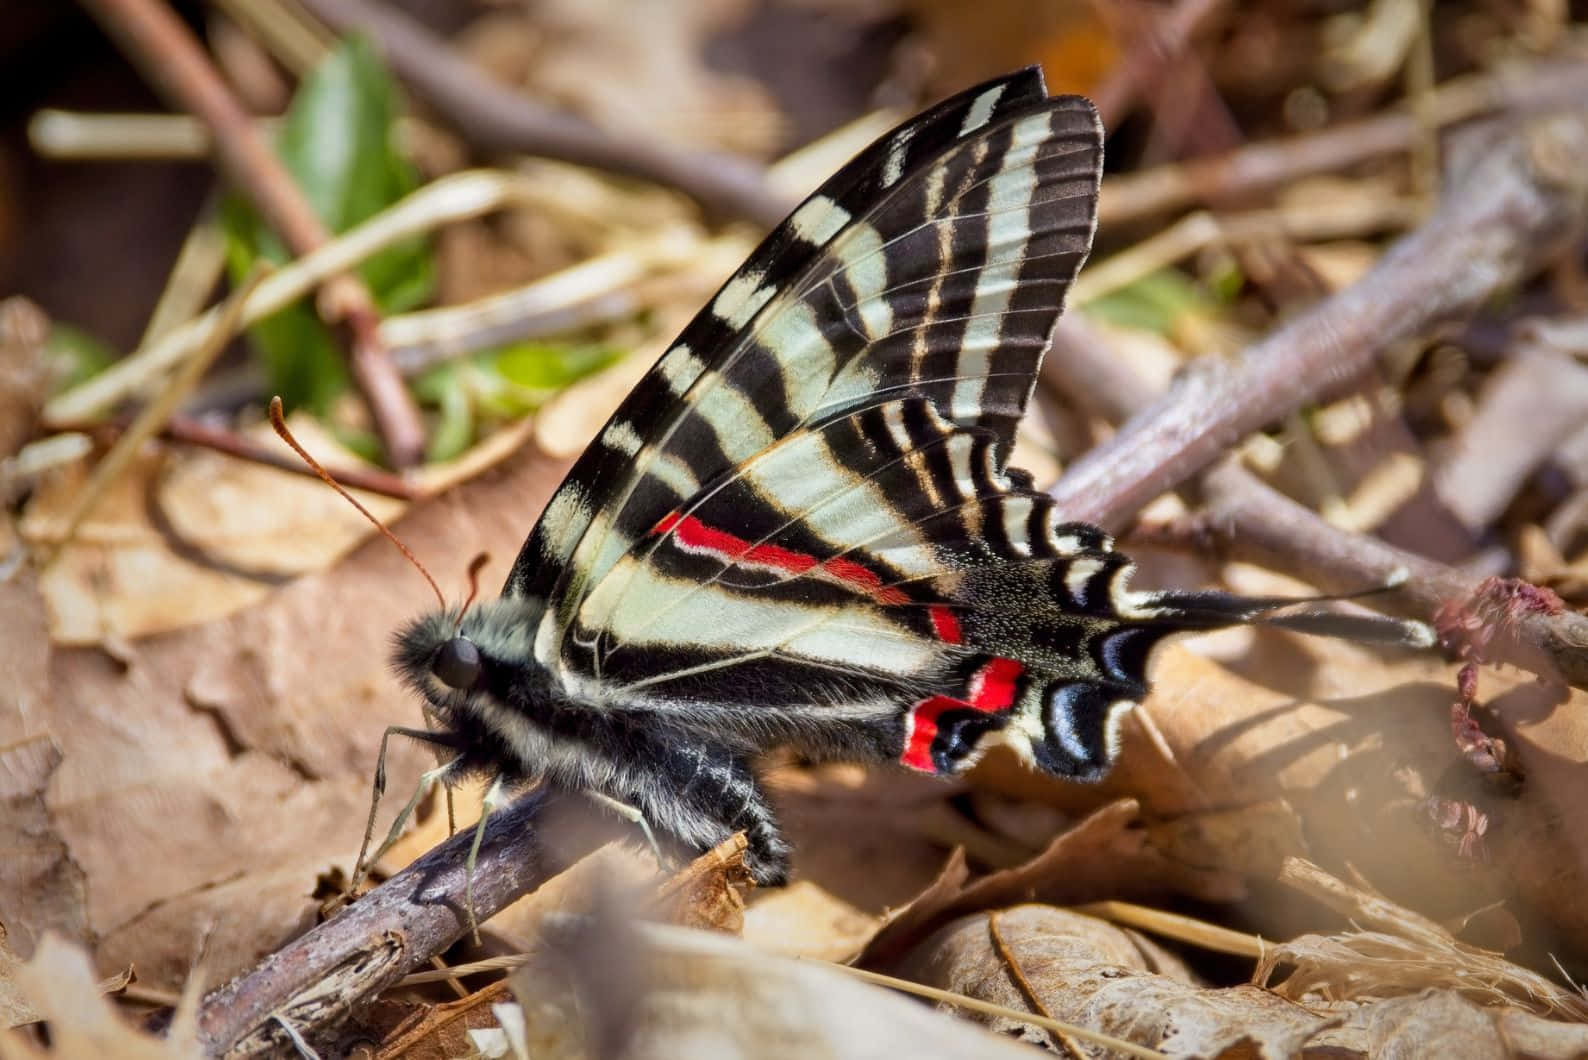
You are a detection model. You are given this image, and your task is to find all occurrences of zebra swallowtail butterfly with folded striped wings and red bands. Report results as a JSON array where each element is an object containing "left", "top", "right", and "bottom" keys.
[{"left": 395, "top": 68, "right": 1429, "bottom": 884}]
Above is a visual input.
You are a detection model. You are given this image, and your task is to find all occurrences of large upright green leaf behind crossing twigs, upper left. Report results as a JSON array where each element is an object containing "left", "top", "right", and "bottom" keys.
[{"left": 221, "top": 38, "right": 435, "bottom": 413}]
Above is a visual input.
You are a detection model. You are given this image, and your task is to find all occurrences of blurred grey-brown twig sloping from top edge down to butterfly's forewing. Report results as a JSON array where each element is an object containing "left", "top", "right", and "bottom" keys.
[{"left": 295, "top": 0, "right": 796, "bottom": 227}]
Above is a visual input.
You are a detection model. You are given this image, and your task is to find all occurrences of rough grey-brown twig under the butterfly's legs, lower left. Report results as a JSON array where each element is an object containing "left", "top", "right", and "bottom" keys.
[{"left": 199, "top": 790, "right": 556, "bottom": 1055}]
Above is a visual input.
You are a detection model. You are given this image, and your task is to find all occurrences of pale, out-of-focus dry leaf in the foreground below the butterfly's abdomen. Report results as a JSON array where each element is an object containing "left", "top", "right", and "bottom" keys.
[{"left": 513, "top": 914, "right": 1048, "bottom": 1060}]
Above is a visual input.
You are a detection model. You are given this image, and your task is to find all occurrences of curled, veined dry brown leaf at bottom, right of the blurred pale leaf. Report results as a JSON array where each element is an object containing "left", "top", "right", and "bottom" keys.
[{"left": 894, "top": 904, "right": 1328, "bottom": 1058}]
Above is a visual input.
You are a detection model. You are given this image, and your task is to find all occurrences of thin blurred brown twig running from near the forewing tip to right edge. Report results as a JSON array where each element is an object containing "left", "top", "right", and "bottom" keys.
[{"left": 1097, "top": 59, "right": 1588, "bottom": 229}]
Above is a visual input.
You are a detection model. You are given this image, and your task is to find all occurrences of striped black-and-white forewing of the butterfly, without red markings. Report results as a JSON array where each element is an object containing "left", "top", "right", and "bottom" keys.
[{"left": 507, "top": 70, "right": 1100, "bottom": 666}]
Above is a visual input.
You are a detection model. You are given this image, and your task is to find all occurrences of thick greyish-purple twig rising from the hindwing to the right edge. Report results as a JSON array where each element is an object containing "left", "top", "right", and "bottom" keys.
[{"left": 1053, "top": 107, "right": 1588, "bottom": 527}]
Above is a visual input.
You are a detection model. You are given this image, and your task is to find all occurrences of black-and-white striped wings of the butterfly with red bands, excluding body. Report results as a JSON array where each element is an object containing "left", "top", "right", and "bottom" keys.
[{"left": 507, "top": 70, "right": 1145, "bottom": 773}]
